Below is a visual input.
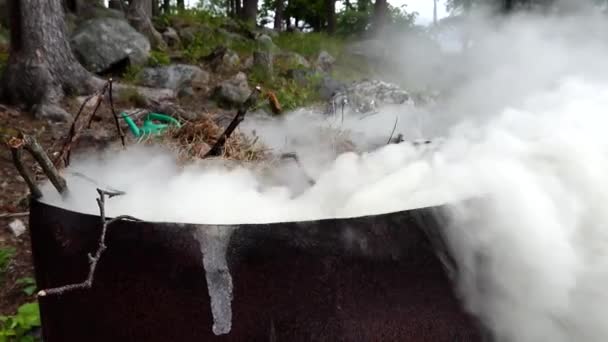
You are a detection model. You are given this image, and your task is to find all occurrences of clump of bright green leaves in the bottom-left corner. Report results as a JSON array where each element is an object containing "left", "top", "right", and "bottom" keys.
[{"left": 0, "top": 302, "right": 40, "bottom": 342}]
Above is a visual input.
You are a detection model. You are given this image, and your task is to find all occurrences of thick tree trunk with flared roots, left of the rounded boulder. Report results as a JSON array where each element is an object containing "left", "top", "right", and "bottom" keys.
[{"left": 2, "top": 0, "right": 100, "bottom": 120}]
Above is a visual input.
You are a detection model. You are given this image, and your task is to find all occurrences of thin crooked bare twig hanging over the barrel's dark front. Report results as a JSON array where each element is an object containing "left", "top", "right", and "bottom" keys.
[{"left": 38, "top": 189, "right": 141, "bottom": 297}]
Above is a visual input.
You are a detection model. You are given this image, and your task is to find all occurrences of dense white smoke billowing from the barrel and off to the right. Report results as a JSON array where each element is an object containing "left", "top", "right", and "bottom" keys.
[{"left": 39, "top": 8, "right": 608, "bottom": 342}]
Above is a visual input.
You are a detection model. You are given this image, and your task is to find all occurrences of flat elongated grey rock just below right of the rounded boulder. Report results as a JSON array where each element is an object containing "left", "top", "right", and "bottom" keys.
[{"left": 140, "top": 64, "right": 209, "bottom": 93}]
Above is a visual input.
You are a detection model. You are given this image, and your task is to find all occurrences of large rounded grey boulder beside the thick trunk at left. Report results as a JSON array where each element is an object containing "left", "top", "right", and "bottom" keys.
[{"left": 71, "top": 18, "right": 150, "bottom": 73}]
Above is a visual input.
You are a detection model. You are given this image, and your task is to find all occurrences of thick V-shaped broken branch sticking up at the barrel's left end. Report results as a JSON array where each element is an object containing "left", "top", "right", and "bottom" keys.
[{"left": 8, "top": 133, "right": 68, "bottom": 199}]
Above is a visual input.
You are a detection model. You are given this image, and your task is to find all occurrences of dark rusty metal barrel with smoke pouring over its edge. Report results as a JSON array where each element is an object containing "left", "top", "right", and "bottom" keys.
[{"left": 30, "top": 201, "right": 480, "bottom": 342}]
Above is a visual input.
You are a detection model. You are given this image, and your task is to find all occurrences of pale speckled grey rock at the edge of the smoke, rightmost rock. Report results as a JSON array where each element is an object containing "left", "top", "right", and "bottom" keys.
[{"left": 332, "top": 80, "right": 414, "bottom": 113}]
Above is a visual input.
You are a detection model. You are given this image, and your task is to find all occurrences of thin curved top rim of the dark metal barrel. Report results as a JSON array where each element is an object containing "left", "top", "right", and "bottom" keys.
[{"left": 30, "top": 197, "right": 450, "bottom": 228}]
